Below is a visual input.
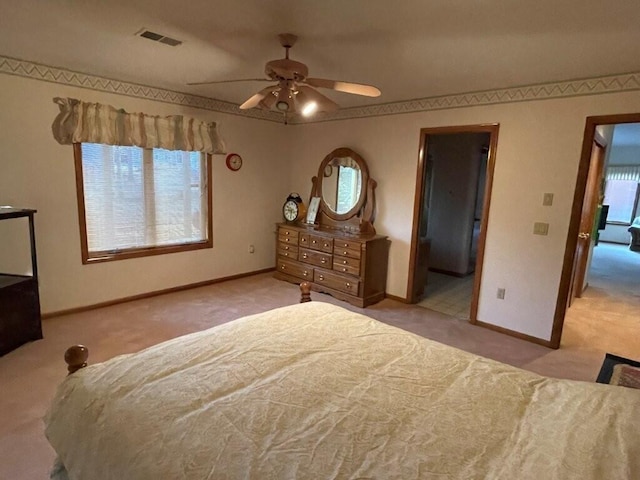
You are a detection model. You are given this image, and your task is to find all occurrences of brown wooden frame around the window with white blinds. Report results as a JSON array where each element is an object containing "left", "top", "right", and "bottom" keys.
[{"left": 73, "top": 143, "right": 213, "bottom": 265}]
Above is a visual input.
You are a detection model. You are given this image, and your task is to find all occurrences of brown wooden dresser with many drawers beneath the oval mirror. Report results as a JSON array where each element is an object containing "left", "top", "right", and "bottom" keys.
[{"left": 274, "top": 223, "right": 389, "bottom": 307}]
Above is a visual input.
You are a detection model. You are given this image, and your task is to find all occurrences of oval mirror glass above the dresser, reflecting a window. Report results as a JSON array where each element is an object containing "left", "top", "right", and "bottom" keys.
[{"left": 322, "top": 157, "right": 362, "bottom": 214}]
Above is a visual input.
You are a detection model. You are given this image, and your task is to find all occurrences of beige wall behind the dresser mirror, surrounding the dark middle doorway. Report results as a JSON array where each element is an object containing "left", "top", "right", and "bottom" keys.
[{"left": 290, "top": 92, "right": 640, "bottom": 340}]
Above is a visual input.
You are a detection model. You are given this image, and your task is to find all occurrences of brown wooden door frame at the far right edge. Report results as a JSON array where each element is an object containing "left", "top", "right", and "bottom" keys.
[{"left": 549, "top": 113, "right": 640, "bottom": 348}]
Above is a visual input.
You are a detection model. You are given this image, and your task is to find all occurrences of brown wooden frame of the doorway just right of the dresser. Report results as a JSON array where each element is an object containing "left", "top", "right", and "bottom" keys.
[{"left": 407, "top": 123, "right": 500, "bottom": 324}]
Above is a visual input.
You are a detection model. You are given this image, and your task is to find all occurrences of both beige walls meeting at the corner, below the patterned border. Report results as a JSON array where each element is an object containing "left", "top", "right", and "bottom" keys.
[{"left": 0, "top": 69, "right": 640, "bottom": 339}]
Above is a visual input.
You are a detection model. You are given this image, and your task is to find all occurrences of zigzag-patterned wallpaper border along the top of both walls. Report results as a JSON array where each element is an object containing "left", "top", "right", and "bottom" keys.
[{"left": 0, "top": 55, "right": 640, "bottom": 124}]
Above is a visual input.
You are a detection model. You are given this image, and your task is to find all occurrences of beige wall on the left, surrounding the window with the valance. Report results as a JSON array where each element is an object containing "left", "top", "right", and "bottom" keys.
[{"left": 0, "top": 75, "right": 290, "bottom": 312}]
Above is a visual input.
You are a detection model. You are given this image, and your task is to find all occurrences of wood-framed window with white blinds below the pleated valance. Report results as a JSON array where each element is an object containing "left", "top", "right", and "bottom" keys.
[{"left": 75, "top": 143, "right": 212, "bottom": 263}]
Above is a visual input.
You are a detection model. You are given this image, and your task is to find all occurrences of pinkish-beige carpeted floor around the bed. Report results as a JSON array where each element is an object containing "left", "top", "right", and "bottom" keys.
[{"left": 0, "top": 248, "right": 640, "bottom": 480}]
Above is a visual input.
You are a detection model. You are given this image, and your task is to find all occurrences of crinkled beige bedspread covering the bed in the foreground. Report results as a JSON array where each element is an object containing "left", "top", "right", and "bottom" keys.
[{"left": 46, "top": 302, "right": 640, "bottom": 480}]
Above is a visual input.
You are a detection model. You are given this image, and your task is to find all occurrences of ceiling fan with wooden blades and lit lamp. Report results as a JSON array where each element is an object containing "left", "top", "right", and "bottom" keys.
[{"left": 187, "top": 33, "right": 380, "bottom": 118}]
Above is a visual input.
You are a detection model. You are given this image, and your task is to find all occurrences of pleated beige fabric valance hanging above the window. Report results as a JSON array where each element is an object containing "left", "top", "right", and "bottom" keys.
[{"left": 51, "top": 97, "right": 226, "bottom": 153}]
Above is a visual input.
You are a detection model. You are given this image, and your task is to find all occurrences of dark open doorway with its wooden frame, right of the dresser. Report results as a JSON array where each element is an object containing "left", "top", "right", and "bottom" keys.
[{"left": 407, "top": 124, "right": 498, "bottom": 323}]
